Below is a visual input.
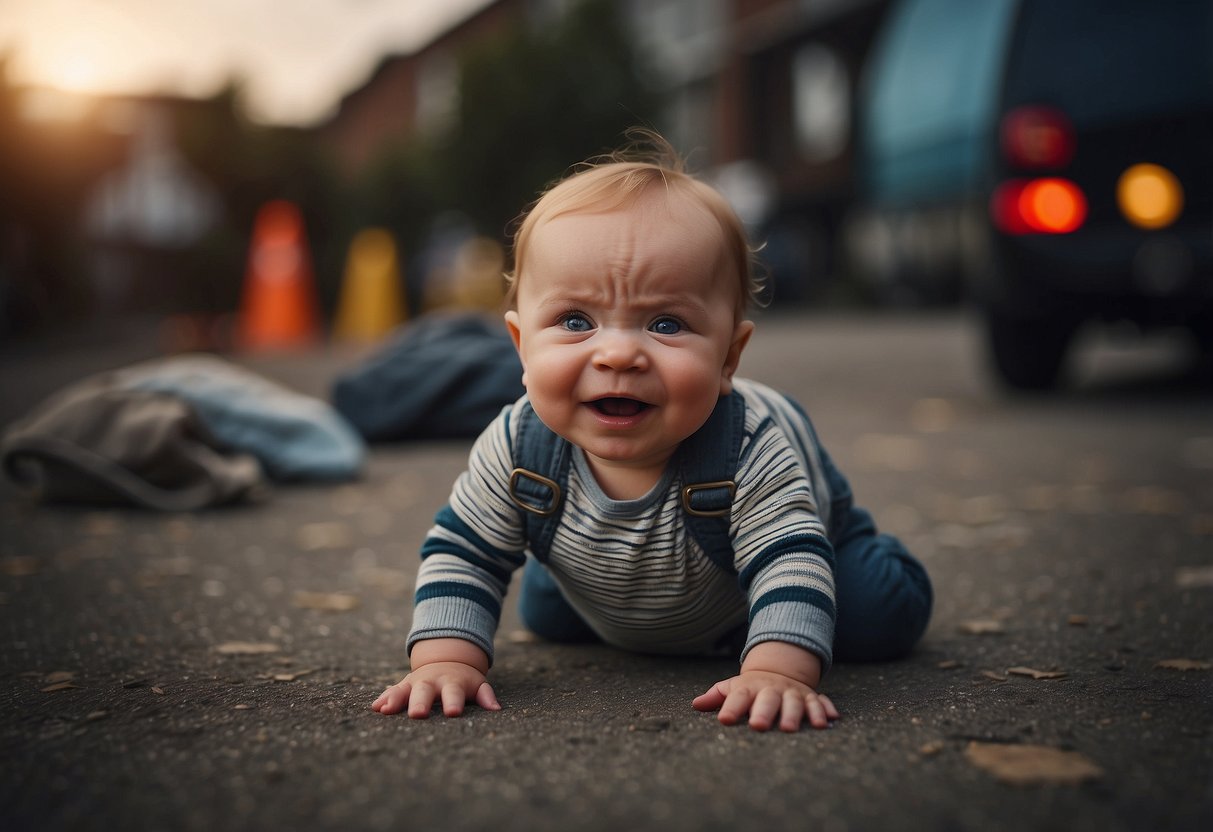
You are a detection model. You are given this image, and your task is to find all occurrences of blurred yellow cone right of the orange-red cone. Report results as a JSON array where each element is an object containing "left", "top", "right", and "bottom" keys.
[{"left": 334, "top": 228, "right": 408, "bottom": 342}]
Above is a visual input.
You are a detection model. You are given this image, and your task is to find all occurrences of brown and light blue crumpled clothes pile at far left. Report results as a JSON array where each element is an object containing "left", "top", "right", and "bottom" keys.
[{"left": 0, "top": 354, "right": 366, "bottom": 511}]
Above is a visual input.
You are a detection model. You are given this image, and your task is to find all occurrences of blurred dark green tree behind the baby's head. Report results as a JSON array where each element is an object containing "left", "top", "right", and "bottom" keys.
[{"left": 341, "top": 0, "right": 657, "bottom": 309}]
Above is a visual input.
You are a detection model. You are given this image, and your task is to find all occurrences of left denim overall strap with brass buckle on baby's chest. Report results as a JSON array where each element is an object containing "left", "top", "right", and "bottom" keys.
[{"left": 509, "top": 401, "right": 571, "bottom": 563}]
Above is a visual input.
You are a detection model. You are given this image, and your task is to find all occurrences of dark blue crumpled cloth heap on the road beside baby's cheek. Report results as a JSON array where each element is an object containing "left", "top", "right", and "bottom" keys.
[{"left": 331, "top": 313, "right": 524, "bottom": 441}]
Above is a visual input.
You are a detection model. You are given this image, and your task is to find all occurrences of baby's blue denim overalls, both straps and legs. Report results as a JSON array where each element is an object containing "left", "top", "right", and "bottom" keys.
[{"left": 509, "top": 393, "right": 933, "bottom": 661}]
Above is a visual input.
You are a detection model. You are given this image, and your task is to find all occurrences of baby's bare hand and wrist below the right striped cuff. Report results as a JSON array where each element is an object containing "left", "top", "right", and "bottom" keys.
[{"left": 691, "top": 642, "right": 838, "bottom": 731}]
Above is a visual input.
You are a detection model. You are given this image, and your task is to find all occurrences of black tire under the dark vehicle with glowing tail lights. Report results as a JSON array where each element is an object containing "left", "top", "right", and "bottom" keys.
[{"left": 986, "top": 307, "right": 1077, "bottom": 391}]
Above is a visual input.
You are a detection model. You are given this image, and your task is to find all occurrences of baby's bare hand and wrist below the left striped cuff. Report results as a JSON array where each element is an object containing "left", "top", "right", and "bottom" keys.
[{"left": 371, "top": 638, "right": 501, "bottom": 719}]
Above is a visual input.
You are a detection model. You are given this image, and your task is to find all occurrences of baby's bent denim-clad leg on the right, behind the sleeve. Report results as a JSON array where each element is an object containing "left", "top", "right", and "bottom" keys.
[{"left": 835, "top": 507, "right": 933, "bottom": 661}]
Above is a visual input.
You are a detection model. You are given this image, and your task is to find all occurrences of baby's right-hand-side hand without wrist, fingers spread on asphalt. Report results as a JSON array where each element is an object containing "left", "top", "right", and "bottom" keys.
[{"left": 691, "top": 671, "right": 839, "bottom": 731}]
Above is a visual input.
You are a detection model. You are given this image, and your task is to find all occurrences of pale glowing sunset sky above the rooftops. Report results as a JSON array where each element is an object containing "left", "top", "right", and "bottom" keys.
[{"left": 0, "top": 0, "right": 491, "bottom": 125}]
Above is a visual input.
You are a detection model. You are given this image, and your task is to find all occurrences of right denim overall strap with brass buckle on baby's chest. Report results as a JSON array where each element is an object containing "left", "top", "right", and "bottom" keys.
[{"left": 679, "top": 393, "right": 746, "bottom": 572}]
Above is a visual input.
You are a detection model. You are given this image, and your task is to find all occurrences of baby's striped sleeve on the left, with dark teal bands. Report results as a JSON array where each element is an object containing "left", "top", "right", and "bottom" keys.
[{"left": 408, "top": 408, "right": 525, "bottom": 662}]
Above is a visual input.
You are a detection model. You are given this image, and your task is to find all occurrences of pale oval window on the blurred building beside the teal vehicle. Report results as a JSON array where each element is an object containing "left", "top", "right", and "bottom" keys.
[{"left": 792, "top": 44, "right": 852, "bottom": 163}]
